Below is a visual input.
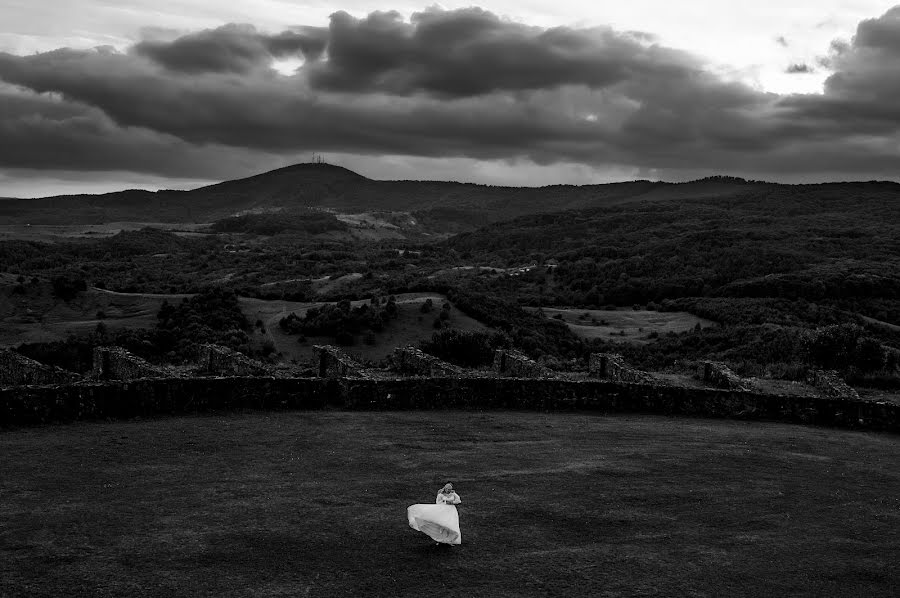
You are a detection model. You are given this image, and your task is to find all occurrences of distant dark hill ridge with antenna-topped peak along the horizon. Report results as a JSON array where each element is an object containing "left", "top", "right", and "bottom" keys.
[{"left": 0, "top": 163, "right": 900, "bottom": 238}]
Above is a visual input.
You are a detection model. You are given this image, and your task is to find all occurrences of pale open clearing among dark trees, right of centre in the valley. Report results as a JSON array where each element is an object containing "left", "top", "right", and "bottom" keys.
[{"left": 543, "top": 307, "right": 718, "bottom": 343}]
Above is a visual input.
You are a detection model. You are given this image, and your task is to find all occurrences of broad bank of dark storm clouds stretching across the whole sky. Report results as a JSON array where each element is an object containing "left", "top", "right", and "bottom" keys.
[{"left": 0, "top": 9, "right": 900, "bottom": 183}]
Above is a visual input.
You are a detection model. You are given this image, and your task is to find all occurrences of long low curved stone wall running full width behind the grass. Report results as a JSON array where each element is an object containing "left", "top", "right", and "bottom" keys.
[{"left": 0, "top": 377, "right": 900, "bottom": 434}]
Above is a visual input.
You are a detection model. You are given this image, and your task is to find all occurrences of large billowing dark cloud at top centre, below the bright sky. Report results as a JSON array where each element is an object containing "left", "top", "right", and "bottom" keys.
[{"left": 307, "top": 8, "right": 694, "bottom": 97}]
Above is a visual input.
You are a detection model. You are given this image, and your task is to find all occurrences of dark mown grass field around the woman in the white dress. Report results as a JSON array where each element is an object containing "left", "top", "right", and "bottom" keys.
[{"left": 0, "top": 412, "right": 900, "bottom": 598}]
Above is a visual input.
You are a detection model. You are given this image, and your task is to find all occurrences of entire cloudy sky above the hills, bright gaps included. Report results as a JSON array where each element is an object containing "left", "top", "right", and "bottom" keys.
[{"left": 0, "top": 0, "right": 900, "bottom": 197}]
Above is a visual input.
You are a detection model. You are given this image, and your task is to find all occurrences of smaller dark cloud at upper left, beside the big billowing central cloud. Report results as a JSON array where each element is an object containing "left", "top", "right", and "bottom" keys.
[{"left": 132, "top": 25, "right": 325, "bottom": 73}]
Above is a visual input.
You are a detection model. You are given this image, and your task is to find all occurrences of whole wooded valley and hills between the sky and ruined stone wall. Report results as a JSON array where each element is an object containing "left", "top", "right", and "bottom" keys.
[{"left": 0, "top": 164, "right": 900, "bottom": 396}]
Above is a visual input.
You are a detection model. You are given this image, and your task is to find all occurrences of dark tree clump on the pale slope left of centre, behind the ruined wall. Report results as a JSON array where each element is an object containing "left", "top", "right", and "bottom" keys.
[{"left": 278, "top": 295, "right": 399, "bottom": 346}]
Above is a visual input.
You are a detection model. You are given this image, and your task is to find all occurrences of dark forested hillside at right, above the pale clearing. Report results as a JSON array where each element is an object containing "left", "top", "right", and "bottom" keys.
[{"left": 446, "top": 188, "right": 900, "bottom": 323}]
